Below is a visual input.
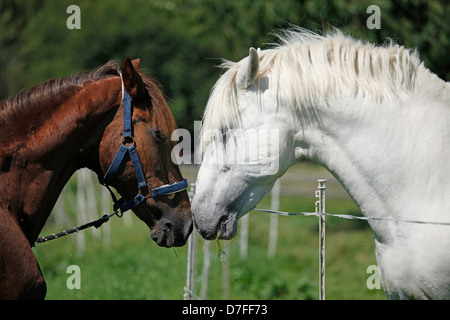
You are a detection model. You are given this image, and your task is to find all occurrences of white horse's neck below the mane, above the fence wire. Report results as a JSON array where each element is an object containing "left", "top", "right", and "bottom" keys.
[{"left": 302, "top": 82, "right": 450, "bottom": 239}]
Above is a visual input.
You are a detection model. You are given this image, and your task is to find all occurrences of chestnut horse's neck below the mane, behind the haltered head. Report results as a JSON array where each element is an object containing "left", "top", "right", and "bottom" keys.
[{"left": 0, "top": 77, "right": 121, "bottom": 244}]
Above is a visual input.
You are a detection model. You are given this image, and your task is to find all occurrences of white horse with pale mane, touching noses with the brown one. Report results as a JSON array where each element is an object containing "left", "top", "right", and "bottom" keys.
[{"left": 192, "top": 29, "right": 450, "bottom": 299}]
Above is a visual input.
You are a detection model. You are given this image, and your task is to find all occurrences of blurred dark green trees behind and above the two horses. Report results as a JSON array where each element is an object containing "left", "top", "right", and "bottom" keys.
[{"left": 0, "top": 0, "right": 450, "bottom": 130}]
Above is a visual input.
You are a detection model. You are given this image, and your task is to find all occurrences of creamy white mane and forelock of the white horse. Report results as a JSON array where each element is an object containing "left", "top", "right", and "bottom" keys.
[{"left": 202, "top": 28, "right": 421, "bottom": 146}]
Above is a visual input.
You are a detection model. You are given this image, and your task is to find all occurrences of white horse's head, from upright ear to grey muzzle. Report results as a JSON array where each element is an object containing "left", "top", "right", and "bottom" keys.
[{"left": 192, "top": 48, "right": 295, "bottom": 239}]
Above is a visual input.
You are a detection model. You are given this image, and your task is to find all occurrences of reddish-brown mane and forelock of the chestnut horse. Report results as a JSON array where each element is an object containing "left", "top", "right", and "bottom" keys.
[{"left": 0, "top": 60, "right": 175, "bottom": 137}]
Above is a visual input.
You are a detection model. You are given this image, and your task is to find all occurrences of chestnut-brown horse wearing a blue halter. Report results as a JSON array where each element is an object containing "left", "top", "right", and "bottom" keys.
[{"left": 0, "top": 59, "right": 192, "bottom": 299}]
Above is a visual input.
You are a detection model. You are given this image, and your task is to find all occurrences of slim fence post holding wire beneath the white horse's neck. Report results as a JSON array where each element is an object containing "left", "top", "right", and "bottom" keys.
[{"left": 316, "top": 179, "right": 327, "bottom": 300}]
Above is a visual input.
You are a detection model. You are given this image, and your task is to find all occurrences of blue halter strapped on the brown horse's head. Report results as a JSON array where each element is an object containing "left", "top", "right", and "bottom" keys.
[{"left": 99, "top": 77, "right": 188, "bottom": 214}]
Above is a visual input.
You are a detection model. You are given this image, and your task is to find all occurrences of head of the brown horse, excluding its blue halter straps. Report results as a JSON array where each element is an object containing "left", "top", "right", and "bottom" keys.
[{"left": 99, "top": 59, "right": 192, "bottom": 247}]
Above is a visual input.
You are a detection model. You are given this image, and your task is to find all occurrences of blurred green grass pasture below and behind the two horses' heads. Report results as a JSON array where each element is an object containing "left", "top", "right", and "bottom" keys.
[{"left": 33, "top": 162, "right": 386, "bottom": 300}]
